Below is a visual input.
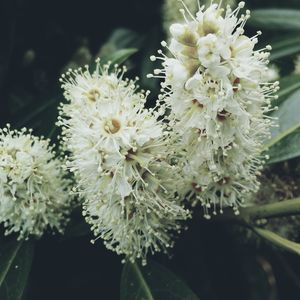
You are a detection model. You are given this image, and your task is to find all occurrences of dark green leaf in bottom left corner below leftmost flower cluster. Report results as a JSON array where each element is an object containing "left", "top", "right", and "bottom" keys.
[{"left": 0, "top": 241, "right": 34, "bottom": 300}]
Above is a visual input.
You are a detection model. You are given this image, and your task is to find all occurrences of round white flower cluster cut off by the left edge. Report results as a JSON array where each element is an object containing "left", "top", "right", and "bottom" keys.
[{"left": 0, "top": 125, "right": 71, "bottom": 239}]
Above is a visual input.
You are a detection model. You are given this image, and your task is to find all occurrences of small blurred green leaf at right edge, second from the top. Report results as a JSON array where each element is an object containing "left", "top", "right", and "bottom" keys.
[{"left": 270, "top": 35, "right": 300, "bottom": 60}]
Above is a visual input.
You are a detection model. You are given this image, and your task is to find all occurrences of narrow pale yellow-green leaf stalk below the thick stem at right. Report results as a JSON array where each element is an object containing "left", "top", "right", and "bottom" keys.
[{"left": 253, "top": 228, "right": 300, "bottom": 255}]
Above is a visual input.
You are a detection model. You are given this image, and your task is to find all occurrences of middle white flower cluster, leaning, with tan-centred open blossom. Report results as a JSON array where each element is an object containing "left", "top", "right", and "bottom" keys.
[{"left": 58, "top": 61, "right": 188, "bottom": 262}]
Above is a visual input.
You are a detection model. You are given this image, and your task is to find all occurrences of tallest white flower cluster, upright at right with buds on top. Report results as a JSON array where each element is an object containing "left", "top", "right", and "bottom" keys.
[{"left": 149, "top": 2, "right": 278, "bottom": 218}]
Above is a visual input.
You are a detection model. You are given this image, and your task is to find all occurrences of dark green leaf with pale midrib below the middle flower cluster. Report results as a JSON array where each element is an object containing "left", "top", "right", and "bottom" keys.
[{"left": 121, "top": 262, "right": 199, "bottom": 300}]
